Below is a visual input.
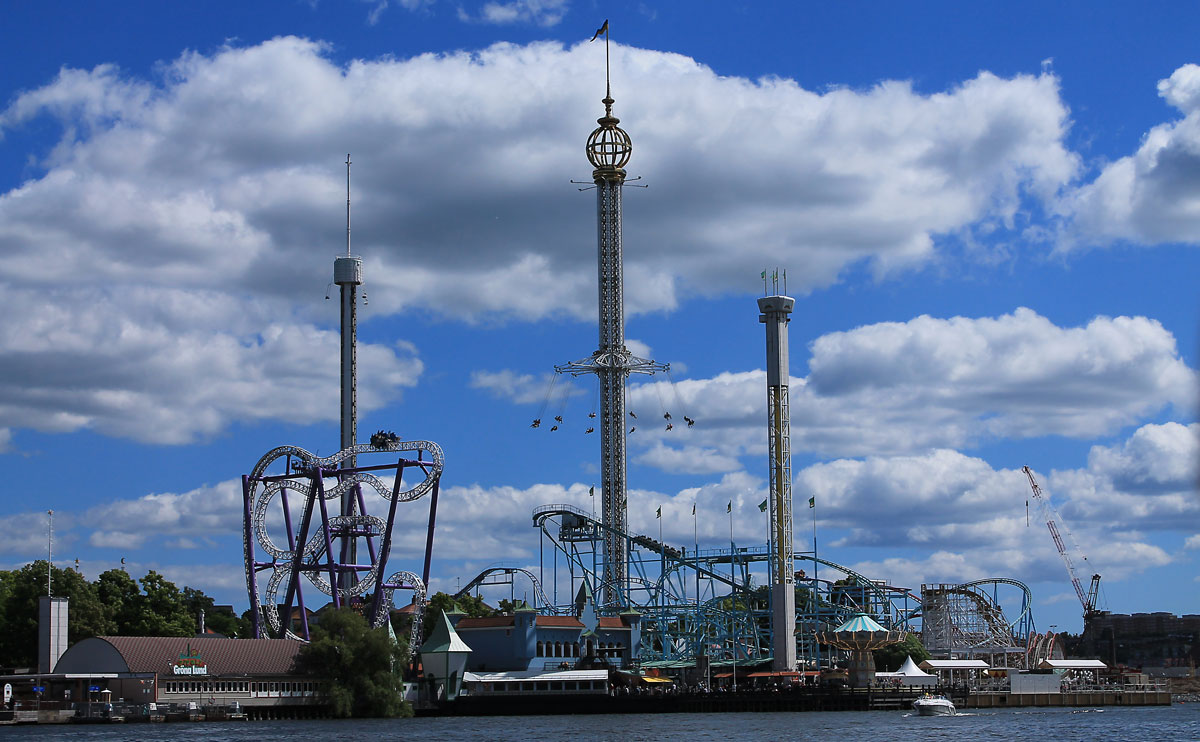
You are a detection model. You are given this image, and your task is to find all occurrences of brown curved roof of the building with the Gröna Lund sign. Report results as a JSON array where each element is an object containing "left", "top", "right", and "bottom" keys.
[{"left": 94, "top": 636, "right": 304, "bottom": 676}]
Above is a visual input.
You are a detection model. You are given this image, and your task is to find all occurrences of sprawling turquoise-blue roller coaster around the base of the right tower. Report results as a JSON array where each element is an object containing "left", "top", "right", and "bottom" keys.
[{"left": 458, "top": 504, "right": 1034, "bottom": 668}]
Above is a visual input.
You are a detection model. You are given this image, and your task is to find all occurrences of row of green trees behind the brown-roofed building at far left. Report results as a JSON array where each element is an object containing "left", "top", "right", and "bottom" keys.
[{"left": 0, "top": 560, "right": 250, "bottom": 668}]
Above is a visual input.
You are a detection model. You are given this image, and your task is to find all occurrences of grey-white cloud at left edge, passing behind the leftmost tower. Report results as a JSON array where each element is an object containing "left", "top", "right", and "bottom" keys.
[{"left": 0, "top": 288, "right": 422, "bottom": 443}]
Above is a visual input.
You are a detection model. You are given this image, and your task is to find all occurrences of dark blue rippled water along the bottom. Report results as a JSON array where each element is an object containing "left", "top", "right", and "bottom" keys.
[{"left": 7, "top": 704, "right": 1200, "bottom": 742}]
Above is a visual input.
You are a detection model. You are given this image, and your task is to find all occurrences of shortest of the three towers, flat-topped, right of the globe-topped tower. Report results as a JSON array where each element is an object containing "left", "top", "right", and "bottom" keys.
[{"left": 758, "top": 285, "right": 796, "bottom": 671}]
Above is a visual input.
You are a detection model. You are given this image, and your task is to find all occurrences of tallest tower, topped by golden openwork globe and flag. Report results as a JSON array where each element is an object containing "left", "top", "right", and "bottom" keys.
[{"left": 554, "top": 28, "right": 668, "bottom": 608}]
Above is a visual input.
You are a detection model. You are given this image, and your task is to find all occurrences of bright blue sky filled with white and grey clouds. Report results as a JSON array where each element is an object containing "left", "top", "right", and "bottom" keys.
[{"left": 0, "top": 0, "right": 1200, "bottom": 630}]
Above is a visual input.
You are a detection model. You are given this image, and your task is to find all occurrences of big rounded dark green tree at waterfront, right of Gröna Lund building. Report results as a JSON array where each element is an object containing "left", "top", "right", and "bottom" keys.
[{"left": 296, "top": 608, "right": 413, "bottom": 718}]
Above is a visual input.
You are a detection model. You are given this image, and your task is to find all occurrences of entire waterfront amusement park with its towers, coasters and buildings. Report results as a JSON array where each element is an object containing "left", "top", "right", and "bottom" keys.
[{"left": 6, "top": 20, "right": 1171, "bottom": 720}]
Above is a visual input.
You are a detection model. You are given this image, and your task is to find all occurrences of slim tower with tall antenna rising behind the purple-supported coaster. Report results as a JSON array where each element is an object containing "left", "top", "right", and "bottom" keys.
[{"left": 334, "top": 155, "right": 362, "bottom": 587}]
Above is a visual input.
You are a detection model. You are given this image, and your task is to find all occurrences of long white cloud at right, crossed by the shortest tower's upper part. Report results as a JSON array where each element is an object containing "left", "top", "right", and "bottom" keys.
[{"left": 629, "top": 303, "right": 1198, "bottom": 458}]
